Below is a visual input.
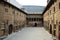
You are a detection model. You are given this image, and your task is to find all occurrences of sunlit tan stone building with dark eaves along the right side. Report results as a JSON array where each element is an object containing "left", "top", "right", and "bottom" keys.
[{"left": 43, "top": 0, "right": 60, "bottom": 40}]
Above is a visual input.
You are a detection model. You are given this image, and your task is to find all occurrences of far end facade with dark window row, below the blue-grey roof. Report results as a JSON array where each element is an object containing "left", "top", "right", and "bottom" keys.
[{"left": 27, "top": 14, "right": 43, "bottom": 27}]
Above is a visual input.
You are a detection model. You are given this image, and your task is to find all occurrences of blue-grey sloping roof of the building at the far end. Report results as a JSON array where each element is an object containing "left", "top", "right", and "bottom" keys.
[{"left": 23, "top": 5, "right": 45, "bottom": 14}]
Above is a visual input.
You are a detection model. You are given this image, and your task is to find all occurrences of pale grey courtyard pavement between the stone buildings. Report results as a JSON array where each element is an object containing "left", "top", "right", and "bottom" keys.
[{"left": 4, "top": 27, "right": 53, "bottom": 40}]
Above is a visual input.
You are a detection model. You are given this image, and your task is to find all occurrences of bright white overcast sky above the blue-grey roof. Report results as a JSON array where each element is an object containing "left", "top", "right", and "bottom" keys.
[{"left": 16, "top": 0, "right": 47, "bottom": 6}]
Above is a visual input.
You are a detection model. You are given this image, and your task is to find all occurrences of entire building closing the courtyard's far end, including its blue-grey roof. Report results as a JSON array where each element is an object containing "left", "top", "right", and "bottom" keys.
[{"left": 23, "top": 5, "right": 45, "bottom": 27}]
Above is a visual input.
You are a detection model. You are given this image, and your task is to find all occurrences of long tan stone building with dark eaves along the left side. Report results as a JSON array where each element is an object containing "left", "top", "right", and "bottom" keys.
[{"left": 0, "top": 1, "right": 26, "bottom": 37}]
